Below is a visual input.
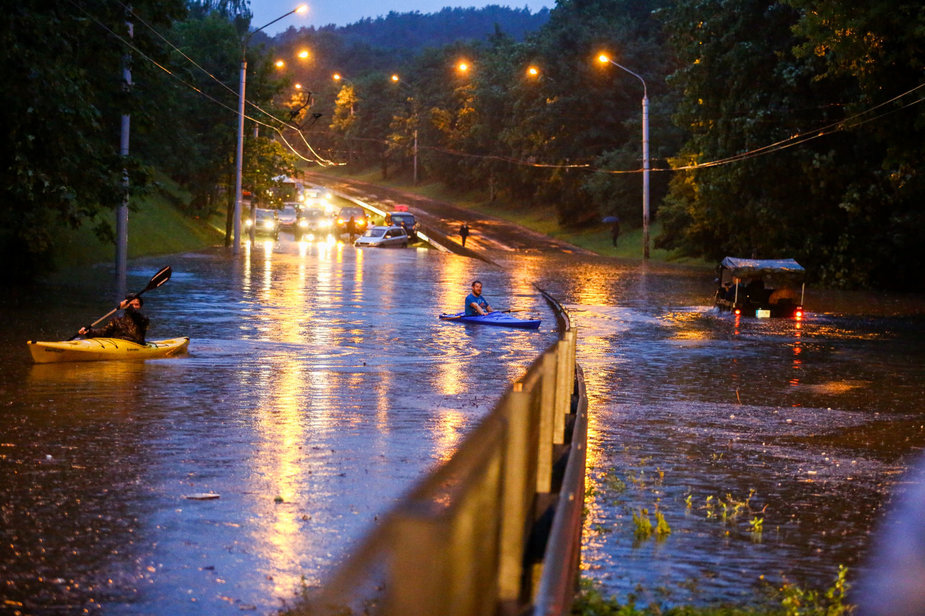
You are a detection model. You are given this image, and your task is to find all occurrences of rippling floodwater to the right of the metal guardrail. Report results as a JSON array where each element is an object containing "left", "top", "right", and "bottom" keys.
[{"left": 511, "top": 254, "right": 925, "bottom": 604}]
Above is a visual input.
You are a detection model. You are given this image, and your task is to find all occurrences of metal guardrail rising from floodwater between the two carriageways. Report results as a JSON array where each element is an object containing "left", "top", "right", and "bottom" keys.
[{"left": 290, "top": 293, "right": 587, "bottom": 616}]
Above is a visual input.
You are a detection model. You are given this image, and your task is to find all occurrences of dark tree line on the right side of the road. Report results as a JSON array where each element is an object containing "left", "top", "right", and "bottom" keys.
[{"left": 287, "top": 0, "right": 925, "bottom": 289}]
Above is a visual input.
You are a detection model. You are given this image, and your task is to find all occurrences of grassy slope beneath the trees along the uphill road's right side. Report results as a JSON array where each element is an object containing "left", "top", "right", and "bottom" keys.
[{"left": 313, "top": 168, "right": 715, "bottom": 269}]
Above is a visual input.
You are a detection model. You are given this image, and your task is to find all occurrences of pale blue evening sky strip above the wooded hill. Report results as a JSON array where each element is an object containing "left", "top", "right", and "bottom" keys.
[{"left": 250, "top": 0, "right": 555, "bottom": 36}]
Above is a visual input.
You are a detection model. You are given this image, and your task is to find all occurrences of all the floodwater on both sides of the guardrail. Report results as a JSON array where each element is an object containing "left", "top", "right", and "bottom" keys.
[{"left": 0, "top": 239, "right": 925, "bottom": 615}]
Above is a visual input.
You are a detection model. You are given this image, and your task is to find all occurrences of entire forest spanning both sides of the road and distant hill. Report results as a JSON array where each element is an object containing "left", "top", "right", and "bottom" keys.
[{"left": 0, "top": 0, "right": 925, "bottom": 290}]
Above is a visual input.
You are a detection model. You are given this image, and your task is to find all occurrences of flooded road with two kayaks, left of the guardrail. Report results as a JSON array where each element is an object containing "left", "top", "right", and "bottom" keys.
[{"left": 0, "top": 239, "right": 557, "bottom": 615}]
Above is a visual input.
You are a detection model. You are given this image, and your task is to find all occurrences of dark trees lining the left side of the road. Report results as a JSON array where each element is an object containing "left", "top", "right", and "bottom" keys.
[{"left": 0, "top": 0, "right": 304, "bottom": 278}]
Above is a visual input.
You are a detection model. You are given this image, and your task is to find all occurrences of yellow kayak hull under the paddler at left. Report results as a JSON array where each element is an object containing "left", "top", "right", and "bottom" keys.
[{"left": 28, "top": 338, "right": 189, "bottom": 364}]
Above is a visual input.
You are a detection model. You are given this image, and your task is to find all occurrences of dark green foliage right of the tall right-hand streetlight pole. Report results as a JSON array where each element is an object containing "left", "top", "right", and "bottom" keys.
[{"left": 658, "top": 0, "right": 925, "bottom": 288}]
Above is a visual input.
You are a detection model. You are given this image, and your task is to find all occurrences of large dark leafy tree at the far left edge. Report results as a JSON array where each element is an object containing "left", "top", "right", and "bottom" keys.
[{"left": 0, "top": 0, "right": 184, "bottom": 276}]
